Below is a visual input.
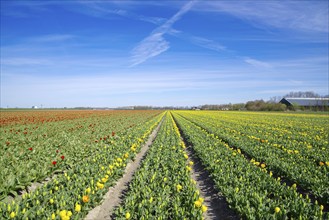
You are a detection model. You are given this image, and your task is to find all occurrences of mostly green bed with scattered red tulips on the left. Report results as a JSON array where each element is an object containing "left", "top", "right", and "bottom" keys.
[{"left": 0, "top": 111, "right": 159, "bottom": 201}]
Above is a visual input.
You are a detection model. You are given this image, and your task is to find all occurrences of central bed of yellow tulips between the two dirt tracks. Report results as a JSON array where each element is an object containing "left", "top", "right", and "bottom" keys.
[{"left": 115, "top": 113, "right": 207, "bottom": 219}]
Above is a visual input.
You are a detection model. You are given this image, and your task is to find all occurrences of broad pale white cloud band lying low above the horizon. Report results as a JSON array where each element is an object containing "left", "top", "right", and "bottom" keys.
[{"left": 0, "top": 66, "right": 328, "bottom": 107}]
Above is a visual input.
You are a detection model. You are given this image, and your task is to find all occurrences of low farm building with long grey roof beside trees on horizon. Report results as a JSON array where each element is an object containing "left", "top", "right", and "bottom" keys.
[{"left": 280, "top": 98, "right": 329, "bottom": 108}]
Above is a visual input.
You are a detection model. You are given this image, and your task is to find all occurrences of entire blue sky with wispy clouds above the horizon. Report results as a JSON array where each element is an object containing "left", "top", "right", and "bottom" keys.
[{"left": 0, "top": 0, "right": 329, "bottom": 107}]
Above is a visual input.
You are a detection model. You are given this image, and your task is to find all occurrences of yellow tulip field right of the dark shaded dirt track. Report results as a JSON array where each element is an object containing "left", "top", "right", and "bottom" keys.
[{"left": 174, "top": 111, "right": 329, "bottom": 219}]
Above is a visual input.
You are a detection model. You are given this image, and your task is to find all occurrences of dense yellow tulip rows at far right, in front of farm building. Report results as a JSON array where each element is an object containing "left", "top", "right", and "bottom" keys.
[{"left": 186, "top": 112, "right": 329, "bottom": 162}]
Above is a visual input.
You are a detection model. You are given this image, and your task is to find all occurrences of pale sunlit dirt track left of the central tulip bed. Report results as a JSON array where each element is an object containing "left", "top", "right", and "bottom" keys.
[{"left": 85, "top": 120, "right": 163, "bottom": 220}]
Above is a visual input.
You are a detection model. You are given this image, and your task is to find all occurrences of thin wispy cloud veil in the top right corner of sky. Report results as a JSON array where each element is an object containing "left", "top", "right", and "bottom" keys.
[{"left": 195, "top": 1, "right": 329, "bottom": 33}]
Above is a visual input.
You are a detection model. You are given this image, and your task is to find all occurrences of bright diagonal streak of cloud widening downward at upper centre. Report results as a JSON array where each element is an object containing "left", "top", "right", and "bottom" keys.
[{"left": 132, "top": 1, "right": 195, "bottom": 66}]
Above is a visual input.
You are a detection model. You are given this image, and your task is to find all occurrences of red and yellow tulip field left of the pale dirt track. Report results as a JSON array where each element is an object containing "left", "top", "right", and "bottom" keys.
[{"left": 0, "top": 111, "right": 164, "bottom": 219}]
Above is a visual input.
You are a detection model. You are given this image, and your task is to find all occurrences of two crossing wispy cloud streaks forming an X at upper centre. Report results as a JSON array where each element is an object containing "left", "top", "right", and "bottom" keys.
[{"left": 73, "top": 1, "right": 229, "bottom": 62}]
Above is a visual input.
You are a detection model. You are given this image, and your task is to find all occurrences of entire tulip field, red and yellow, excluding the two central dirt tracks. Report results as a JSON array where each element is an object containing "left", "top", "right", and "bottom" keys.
[{"left": 0, "top": 110, "right": 329, "bottom": 220}]
